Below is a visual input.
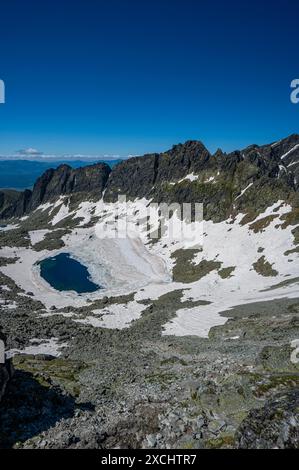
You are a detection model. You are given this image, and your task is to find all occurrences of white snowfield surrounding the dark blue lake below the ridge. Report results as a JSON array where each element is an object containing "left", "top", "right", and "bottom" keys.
[{"left": 0, "top": 198, "right": 299, "bottom": 337}]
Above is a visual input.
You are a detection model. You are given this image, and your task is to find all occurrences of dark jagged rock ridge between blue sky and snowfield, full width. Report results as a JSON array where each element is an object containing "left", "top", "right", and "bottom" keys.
[{"left": 0, "top": 134, "right": 299, "bottom": 221}]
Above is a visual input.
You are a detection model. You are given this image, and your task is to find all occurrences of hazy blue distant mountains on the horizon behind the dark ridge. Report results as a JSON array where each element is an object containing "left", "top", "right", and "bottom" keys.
[{"left": 0, "top": 159, "right": 121, "bottom": 190}]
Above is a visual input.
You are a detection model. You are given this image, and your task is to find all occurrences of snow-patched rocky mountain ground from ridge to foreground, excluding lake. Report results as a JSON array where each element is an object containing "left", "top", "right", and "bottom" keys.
[{"left": 0, "top": 135, "right": 299, "bottom": 449}]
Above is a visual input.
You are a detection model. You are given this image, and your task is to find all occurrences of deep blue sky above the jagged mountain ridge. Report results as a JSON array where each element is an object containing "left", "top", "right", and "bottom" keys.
[{"left": 0, "top": 0, "right": 299, "bottom": 156}]
